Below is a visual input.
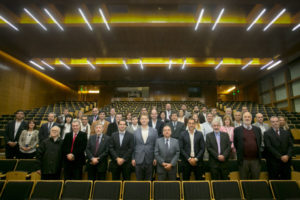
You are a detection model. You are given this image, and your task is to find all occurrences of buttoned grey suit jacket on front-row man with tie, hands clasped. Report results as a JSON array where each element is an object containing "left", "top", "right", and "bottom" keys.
[{"left": 154, "top": 137, "right": 180, "bottom": 173}]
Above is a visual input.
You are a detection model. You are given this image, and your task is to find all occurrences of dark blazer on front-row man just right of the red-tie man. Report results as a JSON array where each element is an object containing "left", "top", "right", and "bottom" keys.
[{"left": 85, "top": 134, "right": 110, "bottom": 172}]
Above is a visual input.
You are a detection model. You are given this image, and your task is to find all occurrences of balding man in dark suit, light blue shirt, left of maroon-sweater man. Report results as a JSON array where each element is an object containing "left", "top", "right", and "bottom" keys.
[{"left": 206, "top": 120, "right": 231, "bottom": 180}]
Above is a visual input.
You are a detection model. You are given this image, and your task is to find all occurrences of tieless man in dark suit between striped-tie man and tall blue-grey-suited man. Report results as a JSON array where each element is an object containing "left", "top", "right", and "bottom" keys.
[{"left": 109, "top": 120, "right": 133, "bottom": 180}]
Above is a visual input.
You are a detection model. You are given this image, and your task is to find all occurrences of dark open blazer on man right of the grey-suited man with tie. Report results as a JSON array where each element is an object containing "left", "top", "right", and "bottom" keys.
[{"left": 179, "top": 130, "right": 205, "bottom": 164}]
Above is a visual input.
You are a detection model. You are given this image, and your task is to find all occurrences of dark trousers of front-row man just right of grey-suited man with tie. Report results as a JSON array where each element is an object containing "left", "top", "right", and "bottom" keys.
[{"left": 182, "top": 161, "right": 204, "bottom": 180}]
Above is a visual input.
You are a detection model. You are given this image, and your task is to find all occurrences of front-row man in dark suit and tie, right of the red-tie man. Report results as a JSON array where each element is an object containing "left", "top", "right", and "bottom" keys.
[{"left": 85, "top": 124, "right": 109, "bottom": 180}]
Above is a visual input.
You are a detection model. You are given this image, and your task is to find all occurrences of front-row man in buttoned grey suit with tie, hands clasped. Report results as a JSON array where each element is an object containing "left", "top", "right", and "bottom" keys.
[{"left": 154, "top": 125, "right": 180, "bottom": 181}]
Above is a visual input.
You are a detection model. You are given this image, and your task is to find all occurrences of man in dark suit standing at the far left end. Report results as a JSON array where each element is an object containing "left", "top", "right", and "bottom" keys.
[{"left": 4, "top": 110, "right": 27, "bottom": 159}]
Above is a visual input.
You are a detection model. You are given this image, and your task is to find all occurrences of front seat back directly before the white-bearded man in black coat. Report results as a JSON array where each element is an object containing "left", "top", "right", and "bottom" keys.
[{"left": 31, "top": 180, "right": 64, "bottom": 200}]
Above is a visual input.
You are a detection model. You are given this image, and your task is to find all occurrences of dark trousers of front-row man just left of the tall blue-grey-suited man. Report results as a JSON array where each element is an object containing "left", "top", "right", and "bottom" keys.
[{"left": 111, "top": 161, "right": 131, "bottom": 180}]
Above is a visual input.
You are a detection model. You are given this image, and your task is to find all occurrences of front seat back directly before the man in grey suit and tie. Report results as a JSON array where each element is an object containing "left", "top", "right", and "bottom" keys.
[{"left": 153, "top": 181, "right": 181, "bottom": 200}]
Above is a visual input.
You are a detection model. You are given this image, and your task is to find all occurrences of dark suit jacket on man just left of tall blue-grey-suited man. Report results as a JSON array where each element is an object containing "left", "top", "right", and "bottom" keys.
[{"left": 109, "top": 131, "right": 134, "bottom": 164}]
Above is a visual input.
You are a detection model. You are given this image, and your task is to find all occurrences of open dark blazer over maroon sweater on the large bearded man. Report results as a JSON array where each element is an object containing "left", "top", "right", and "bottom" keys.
[{"left": 233, "top": 126, "right": 262, "bottom": 164}]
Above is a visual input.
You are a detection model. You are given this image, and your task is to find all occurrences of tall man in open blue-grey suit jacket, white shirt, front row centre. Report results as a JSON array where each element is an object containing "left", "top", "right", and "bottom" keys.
[{"left": 132, "top": 115, "right": 158, "bottom": 180}]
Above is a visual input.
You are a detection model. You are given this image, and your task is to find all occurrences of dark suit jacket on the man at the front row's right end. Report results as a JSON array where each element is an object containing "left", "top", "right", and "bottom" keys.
[{"left": 264, "top": 128, "right": 293, "bottom": 162}]
